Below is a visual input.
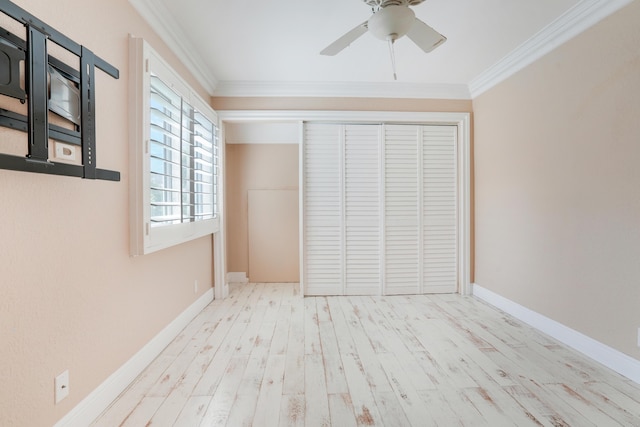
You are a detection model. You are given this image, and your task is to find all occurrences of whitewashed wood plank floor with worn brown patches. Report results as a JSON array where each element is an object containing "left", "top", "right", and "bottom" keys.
[{"left": 94, "top": 284, "right": 640, "bottom": 427}]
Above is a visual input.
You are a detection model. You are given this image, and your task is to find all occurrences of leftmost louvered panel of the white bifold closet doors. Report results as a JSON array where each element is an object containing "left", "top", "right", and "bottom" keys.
[{"left": 303, "top": 123, "right": 344, "bottom": 295}]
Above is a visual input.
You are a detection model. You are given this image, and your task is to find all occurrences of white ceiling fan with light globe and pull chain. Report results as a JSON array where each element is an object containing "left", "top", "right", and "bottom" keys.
[{"left": 320, "top": 0, "right": 447, "bottom": 79}]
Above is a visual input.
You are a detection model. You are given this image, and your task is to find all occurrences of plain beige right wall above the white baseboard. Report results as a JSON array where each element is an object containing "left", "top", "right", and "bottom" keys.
[{"left": 473, "top": 2, "right": 640, "bottom": 359}]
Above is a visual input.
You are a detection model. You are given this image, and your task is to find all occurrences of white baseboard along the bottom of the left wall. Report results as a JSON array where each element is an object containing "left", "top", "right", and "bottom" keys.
[{"left": 54, "top": 288, "right": 213, "bottom": 427}]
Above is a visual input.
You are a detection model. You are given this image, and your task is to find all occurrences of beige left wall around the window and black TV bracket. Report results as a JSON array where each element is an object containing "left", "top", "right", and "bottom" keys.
[{"left": 0, "top": 0, "right": 212, "bottom": 426}]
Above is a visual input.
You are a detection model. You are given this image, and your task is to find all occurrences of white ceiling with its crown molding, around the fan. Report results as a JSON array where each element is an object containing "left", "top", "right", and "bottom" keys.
[{"left": 130, "top": 0, "right": 629, "bottom": 98}]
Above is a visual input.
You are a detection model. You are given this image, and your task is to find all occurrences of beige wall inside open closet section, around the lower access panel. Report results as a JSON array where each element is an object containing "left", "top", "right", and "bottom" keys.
[{"left": 226, "top": 144, "right": 298, "bottom": 277}]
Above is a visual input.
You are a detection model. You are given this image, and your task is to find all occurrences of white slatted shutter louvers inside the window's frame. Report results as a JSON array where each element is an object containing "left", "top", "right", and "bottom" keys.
[{"left": 149, "top": 74, "right": 218, "bottom": 227}]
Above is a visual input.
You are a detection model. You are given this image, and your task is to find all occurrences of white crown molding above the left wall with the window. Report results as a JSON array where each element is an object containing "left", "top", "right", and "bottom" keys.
[{"left": 129, "top": 0, "right": 218, "bottom": 95}]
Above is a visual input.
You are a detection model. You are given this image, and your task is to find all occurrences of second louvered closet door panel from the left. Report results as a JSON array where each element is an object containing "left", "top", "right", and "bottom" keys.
[{"left": 344, "top": 125, "right": 381, "bottom": 295}]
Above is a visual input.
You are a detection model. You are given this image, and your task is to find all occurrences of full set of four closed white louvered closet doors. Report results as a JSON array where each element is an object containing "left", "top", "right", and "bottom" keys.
[{"left": 301, "top": 122, "right": 458, "bottom": 295}]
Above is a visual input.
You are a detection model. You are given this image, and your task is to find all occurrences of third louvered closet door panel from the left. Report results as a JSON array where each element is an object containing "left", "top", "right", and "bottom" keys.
[{"left": 384, "top": 125, "right": 421, "bottom": 295}]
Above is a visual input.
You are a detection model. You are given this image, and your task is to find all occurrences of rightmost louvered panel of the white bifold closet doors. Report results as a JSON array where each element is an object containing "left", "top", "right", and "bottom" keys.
[{"left": 421, "top": 126, "right": 458, "bottom": 293}]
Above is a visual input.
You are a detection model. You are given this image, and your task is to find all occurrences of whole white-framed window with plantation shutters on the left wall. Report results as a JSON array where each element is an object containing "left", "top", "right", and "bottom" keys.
[{"left": 130, "top": 39, "right": 219, "bottom": 255}]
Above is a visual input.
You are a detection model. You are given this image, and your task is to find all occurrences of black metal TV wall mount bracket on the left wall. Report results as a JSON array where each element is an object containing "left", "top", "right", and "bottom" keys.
[{"left": 0, "top": 0, "right": 120, "bottom": 181}]
